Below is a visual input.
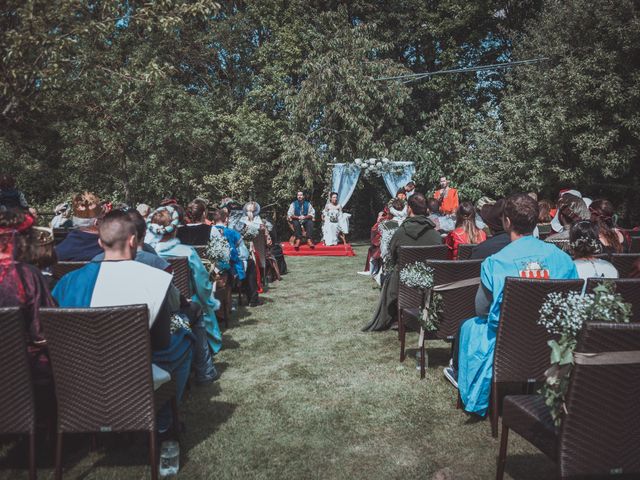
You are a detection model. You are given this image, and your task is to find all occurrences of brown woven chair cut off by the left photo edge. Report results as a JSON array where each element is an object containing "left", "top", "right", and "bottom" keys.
[{"left": 0, "top": 308, "right": 36, "bottom": 480}]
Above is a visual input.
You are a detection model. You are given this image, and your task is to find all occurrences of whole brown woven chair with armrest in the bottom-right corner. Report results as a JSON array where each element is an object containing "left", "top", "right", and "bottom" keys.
[{"left": 496, "top": 323, "right": 640, "bottom": 480}]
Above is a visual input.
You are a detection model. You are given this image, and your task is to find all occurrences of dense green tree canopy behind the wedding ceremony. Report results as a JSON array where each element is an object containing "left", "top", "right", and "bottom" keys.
[{"left": 0, "top": 0, "right": 640, "bottom": 225}]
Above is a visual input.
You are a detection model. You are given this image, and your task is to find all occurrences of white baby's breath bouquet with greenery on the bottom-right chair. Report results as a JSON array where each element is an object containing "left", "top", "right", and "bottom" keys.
[{"left": 538, "top": 282, "right": 631, "bottom": 427}]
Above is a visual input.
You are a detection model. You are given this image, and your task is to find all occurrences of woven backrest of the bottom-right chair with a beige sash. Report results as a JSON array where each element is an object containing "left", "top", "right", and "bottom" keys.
[{"left": 558, "top": 322, "right": 640, "bottom": 478}]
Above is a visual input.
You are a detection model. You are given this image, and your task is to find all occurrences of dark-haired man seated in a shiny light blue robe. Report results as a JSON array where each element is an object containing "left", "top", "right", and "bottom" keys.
[{"left": 445, "top": 194, "right": 578, "bottom": 416}]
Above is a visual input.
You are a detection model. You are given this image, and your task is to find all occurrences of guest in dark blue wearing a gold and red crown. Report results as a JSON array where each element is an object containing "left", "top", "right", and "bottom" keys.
[{"left": 56, "top": 192, "right": 102, "bottom": 262}]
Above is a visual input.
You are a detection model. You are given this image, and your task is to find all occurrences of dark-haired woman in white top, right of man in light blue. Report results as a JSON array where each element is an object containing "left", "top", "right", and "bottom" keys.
[{"left": 569, "top": 220, "right": 618, "bottom": 279}]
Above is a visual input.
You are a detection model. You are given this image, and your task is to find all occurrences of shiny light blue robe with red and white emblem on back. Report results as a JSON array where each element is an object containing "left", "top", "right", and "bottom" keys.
[{"left": 458, "top": 236, "right": 578, "bottom": 416}]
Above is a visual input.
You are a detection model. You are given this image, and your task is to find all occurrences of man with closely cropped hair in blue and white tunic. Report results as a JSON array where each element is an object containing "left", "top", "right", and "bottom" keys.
[{"left": 53, "top": 211, "right": 192, "bottom": 432}]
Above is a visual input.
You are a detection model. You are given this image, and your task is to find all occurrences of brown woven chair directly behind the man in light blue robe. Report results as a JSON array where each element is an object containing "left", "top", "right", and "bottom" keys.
[{"left": 491, "top": 277, "right": 584, "bottom": 437}]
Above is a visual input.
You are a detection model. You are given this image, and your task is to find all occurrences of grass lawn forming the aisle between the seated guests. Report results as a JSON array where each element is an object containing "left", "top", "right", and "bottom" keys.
[{"left": 0, "top": 246, "right": 554, "bottom": 480}]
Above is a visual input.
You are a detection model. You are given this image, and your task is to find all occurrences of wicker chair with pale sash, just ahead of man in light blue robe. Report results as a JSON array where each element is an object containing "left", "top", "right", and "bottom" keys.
[{"left": 411, "top": 260, "right": 482, "bottom": 378}]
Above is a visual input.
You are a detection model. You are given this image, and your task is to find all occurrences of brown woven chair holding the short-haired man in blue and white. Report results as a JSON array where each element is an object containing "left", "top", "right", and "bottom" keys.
[{"left": 40, "top": 305, "right": 178, "bottom": 480}]
